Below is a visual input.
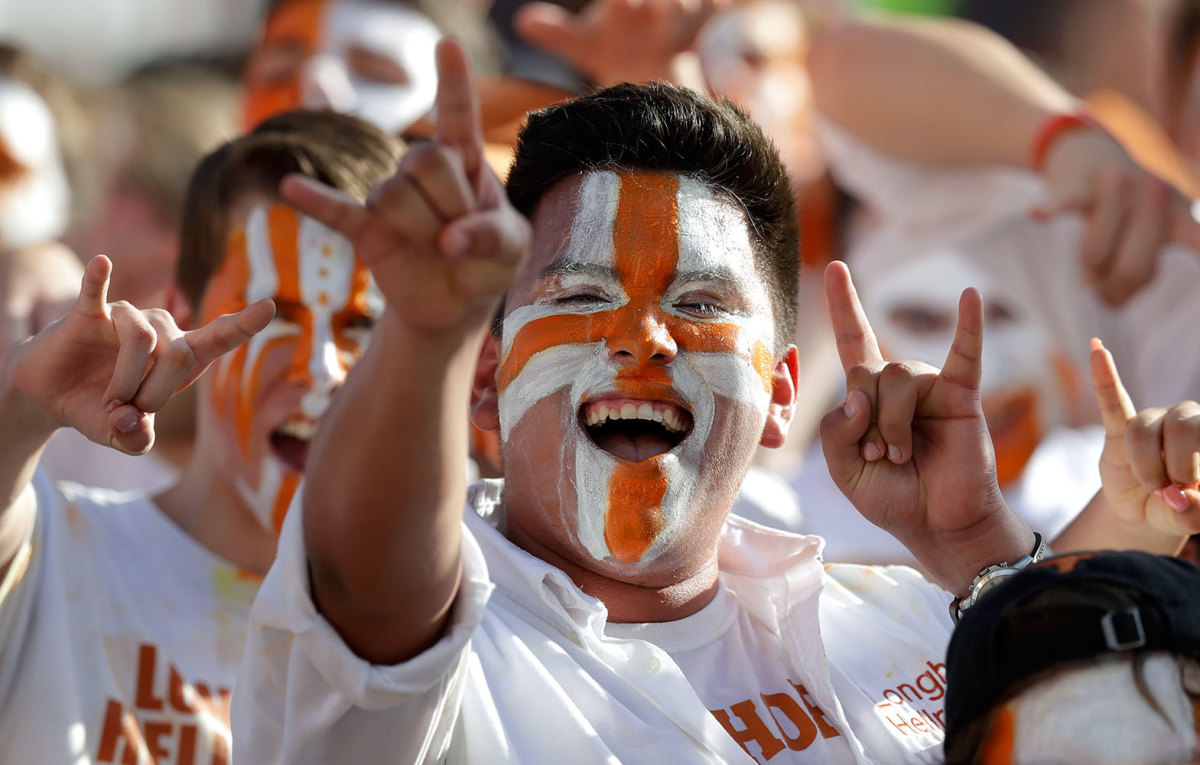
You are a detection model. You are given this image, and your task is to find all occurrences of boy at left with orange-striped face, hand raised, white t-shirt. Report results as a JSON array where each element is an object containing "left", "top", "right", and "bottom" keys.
[{"left": 0, "top": 113, "right": 398, "bottom": 765}]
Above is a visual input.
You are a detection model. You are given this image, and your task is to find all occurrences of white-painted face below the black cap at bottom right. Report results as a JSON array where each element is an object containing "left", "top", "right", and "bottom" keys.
[{"left": 980, "top": 653, "right": 1200, "bottom": 765}]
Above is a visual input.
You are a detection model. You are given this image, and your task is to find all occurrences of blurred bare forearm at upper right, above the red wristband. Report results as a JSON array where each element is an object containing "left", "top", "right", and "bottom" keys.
[{"left": 809, "top": 14, "right": 1080, "bottom": 167}]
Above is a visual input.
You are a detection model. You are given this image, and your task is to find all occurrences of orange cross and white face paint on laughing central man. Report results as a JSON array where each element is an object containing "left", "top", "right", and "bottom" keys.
[{"left": 498, "top": 171, "right": 773, "bottom": 564}]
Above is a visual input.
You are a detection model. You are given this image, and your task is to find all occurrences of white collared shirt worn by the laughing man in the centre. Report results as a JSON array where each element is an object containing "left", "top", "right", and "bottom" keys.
[{"left": 233, "top": 481, "right": 950, "bottom": 765}]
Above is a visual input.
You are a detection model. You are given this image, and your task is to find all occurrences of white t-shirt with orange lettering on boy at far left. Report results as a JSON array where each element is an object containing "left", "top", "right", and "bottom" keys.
[{"left": 0, "top": 471, "right": 257, "bottom": 765}]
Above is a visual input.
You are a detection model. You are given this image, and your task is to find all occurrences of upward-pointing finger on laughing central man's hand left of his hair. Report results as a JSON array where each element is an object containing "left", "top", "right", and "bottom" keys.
[{"left": 437, "top": 37, "right": 484, "bottom": 182}]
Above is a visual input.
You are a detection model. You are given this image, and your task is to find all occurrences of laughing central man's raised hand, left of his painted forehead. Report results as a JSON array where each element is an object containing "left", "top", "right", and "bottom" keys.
[{"left": 280, "top": 40, "right": 529, "bottom": 331}]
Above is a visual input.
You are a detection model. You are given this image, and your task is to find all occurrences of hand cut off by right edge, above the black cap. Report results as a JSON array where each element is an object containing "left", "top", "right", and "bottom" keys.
[{"left": 1090, "top": 339, "right": 1200, "bottom": 535}]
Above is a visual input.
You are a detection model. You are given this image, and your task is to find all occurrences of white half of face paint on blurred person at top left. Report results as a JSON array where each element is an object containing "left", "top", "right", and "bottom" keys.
[{"left": 302, "top": 0, "right": 442, "bottom": 134}]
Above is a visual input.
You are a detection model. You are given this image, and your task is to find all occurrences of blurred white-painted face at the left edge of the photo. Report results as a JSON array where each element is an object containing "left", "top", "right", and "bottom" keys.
[{"left": 0, "top": 77, "right": 71, "bottom": 249}]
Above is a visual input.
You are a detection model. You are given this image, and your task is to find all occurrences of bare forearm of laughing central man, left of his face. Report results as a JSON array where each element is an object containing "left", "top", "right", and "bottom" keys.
[{"left": 304, "top": 308, "right": 481, "bottom": 663}]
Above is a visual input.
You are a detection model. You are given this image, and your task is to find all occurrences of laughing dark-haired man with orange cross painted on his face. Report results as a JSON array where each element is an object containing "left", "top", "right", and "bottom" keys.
[{"left": 234, "top": 43, "right": 1200, "bottom": 763}]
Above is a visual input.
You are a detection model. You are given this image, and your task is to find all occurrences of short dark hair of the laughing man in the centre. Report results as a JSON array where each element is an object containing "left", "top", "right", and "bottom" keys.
[{"left": 508, "top": 83, "right": 799, "bottom": 351}]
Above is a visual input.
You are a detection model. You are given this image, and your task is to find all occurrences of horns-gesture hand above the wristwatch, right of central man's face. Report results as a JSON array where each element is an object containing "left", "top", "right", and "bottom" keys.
[{"left": 821, "top": 263, "right": 1033, "bottom": 591}]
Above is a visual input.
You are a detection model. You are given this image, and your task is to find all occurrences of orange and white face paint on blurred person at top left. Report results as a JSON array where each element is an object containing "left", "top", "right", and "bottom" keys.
[{"left": 245, "top": 0, "right": 442, "bottom": 134}]
